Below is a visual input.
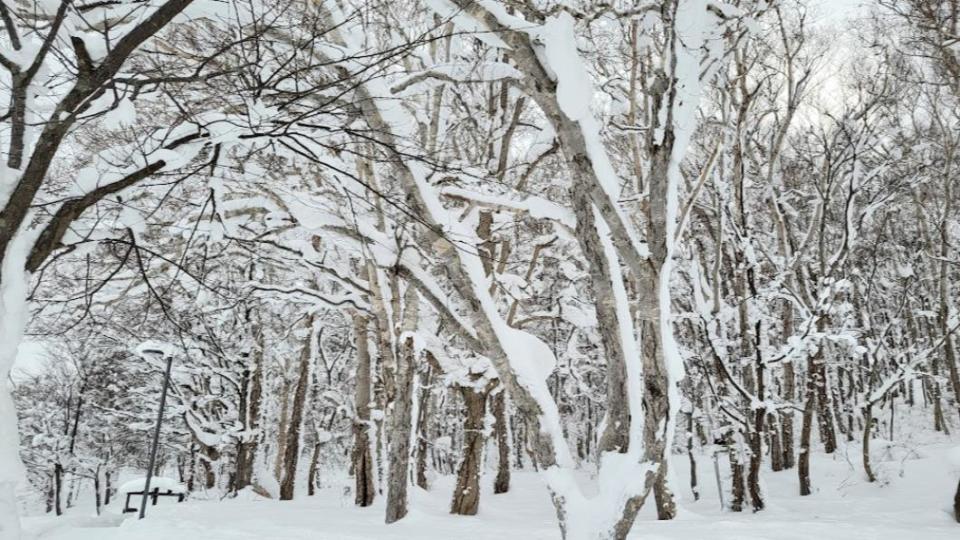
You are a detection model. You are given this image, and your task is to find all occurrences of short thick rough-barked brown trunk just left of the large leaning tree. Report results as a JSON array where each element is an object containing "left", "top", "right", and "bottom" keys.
[{"left": 450, "top": 386, "right": 487, "bottom": 516}]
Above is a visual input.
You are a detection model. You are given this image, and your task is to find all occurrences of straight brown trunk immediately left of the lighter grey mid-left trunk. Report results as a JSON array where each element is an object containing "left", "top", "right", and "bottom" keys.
[{"left": 353, "top": 315, "right": 376, "bottom": 506}]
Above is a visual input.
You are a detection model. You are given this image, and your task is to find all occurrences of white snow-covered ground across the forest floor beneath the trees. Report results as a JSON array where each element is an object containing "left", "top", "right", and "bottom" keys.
[{"left": 18, "top": 443, "right": 960, "bottom": 540}]
